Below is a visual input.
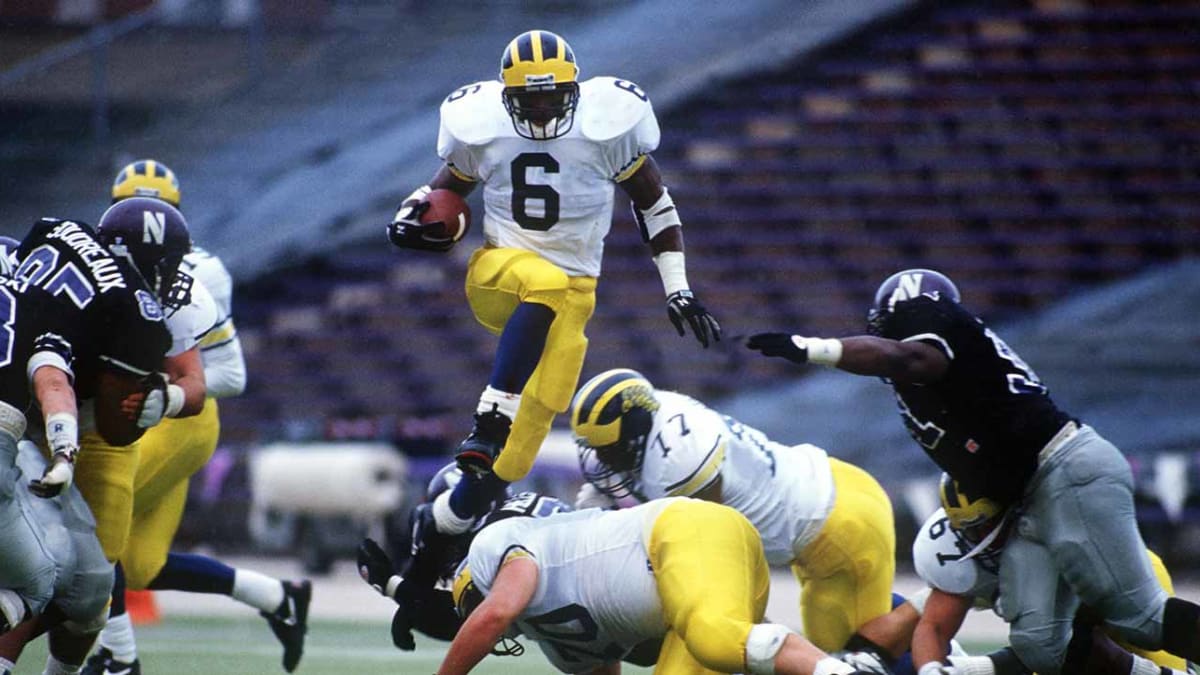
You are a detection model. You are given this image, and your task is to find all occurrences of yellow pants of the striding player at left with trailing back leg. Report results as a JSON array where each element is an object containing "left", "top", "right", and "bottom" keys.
[{"left": 120, "top": 399, "right": 221, "bottom": 590}]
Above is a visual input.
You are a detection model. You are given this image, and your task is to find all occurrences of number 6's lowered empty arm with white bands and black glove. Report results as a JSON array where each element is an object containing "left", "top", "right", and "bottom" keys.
[{"left": 617, "top": 155, "right": 721, "bottom": 348}]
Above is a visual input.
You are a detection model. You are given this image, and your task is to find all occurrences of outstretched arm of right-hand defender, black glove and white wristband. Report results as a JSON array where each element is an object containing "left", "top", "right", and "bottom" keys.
[{"left": 746, "top": 333, "right": 950, "bottom": 382}]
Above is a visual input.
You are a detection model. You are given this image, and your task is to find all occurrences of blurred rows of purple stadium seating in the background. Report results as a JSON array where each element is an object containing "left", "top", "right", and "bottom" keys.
[{"left": 226, "top": 0, "right": 1200, "bottom": 456}]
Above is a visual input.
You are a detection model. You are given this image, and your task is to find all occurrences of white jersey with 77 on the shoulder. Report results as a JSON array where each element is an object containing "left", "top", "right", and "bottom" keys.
[{"left": 636, "top": 392, "right": 834, "bottom": 565}]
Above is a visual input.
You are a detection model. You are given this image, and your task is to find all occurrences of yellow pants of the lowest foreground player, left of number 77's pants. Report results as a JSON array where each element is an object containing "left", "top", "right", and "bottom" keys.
[{"left": 649, "top": 500, "right": 770, "bottom": 675}]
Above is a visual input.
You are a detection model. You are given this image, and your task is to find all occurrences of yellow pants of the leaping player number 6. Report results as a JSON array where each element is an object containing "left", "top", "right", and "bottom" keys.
[{"left": 467, "top": 246, "right": 596, "bottom": 482}]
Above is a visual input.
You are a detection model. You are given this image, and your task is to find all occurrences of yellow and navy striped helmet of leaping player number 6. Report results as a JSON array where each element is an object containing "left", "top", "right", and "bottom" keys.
[{"left": 500, "top": 30, "right": 580, "bottom": 141}]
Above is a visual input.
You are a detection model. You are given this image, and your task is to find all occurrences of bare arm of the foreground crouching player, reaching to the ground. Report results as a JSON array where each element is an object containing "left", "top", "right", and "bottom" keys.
[{"left": 438, "top": 557, "right": 538, "bottom": 675}]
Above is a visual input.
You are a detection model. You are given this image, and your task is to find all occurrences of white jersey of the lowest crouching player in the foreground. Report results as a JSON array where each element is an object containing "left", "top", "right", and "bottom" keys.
[{"left": 467, "top": 500, "right": 670, "bottom": 673}]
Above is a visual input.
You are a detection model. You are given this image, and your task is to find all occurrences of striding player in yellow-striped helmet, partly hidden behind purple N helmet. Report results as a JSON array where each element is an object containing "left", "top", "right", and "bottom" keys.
[{"left": 83, "top": 160, "right": 312, "bottom": 675}]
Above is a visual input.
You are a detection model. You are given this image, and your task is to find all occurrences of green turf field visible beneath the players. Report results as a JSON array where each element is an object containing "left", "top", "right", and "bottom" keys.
[{"left": 16, "top": 616, "right": 992, "bottom": 675}]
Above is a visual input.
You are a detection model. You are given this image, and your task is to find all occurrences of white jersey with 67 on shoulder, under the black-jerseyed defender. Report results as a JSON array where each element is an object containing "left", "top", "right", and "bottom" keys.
[{"left": 912, "top": 508, "right": 1000, "bottom": 608}]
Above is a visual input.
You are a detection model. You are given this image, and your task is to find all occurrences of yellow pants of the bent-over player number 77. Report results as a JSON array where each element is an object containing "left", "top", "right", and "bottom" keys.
[{"left": 792, "top": 458, "right": 896, "bottom": 652}]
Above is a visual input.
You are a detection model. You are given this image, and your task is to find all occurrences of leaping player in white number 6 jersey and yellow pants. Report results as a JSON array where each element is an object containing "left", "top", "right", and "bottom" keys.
[{"left": 388, "top": 30, "right": 721, "bottom": 534}]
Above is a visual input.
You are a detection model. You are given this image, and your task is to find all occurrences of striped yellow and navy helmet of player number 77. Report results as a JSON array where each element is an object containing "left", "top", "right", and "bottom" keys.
[{"left": 571, "top": 368, "right": 659, "bottom": 500}]
